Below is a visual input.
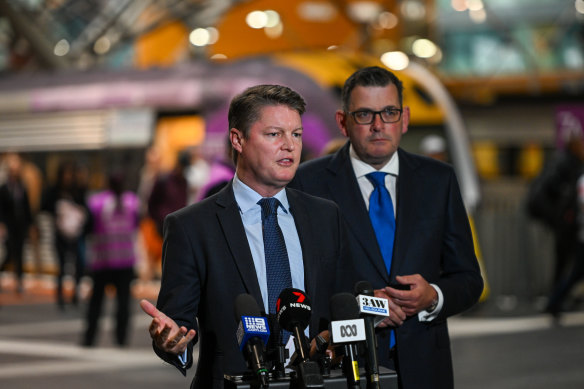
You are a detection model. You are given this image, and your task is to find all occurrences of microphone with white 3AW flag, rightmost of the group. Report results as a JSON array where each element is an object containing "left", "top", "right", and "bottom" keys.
[{"left": 355, "top": 281, "right": 389, "bottom": 389}]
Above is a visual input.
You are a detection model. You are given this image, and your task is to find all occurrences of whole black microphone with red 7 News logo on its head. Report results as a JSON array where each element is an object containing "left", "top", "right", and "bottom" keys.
[{"left": 276, "top": 288, "right": 324, "bottom": 388}]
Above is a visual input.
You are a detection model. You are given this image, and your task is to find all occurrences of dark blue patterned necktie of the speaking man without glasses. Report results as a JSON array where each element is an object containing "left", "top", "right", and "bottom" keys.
[{"left": 258, "top": 197, "right": 292, "bottom": 314}]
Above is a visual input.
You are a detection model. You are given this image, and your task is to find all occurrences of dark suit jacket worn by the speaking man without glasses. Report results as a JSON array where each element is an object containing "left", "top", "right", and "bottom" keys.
[{"left": 155, "top": 183, "right": 348, "bottom": 388}]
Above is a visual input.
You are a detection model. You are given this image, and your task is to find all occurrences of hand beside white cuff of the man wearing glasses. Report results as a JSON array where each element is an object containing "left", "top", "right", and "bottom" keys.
[{"left": 383, "top": 274, "right": 438, "bottom": 316}]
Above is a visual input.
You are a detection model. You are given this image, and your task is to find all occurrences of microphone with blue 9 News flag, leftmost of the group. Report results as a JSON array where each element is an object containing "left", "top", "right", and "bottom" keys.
[{"left": 234, "top": 293, "right": 270, "bottom": 388}]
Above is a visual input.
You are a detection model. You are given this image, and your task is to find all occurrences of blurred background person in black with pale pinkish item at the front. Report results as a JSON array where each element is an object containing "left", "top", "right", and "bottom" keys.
[{"left": 42, "top": 161, "right": 89, "bottom": 309}]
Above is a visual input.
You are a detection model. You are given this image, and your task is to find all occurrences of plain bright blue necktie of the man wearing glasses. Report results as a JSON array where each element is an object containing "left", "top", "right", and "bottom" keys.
[{"left": 366, "top": 172, "right": 395, "bottom": 347}]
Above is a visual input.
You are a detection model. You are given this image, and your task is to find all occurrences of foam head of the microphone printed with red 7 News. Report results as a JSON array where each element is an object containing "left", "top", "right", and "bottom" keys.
[{"left": 276, "top": 288, "right": 312, "bottom": 332}]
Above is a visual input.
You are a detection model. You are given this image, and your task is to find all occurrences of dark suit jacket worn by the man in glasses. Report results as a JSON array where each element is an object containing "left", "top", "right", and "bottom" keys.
[{"left": 290, "top": 143, "right": 483, "bottom": 389}]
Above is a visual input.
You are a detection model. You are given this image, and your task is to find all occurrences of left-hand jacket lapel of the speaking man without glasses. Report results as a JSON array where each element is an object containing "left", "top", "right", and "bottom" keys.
[{"left": 216, "top": 183, "right": 264, "bottom": 307}]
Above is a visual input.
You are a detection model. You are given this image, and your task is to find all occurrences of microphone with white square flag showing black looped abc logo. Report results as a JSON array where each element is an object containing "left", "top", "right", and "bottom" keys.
[{"left": 330, "top": 293, "right": 366, "bottom": 389}]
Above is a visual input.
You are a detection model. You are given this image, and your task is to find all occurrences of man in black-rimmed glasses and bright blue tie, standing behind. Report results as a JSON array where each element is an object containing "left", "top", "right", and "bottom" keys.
[{"left": 290, "top": 67, "right": 483, "bottom": 389}]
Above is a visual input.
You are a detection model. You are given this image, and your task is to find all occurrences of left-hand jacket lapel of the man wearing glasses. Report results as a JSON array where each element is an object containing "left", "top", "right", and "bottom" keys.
[{"left": 326, "top": 142, "right": 389, "bottom": 282}]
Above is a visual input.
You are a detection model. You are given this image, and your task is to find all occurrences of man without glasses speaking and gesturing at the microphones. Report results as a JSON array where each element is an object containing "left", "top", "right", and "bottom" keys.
[{"left": 141, "top": 85, "right": 348, "bottom": 388}]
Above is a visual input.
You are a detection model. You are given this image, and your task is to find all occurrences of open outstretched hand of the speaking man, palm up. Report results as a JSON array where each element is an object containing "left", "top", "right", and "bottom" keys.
[{"left": 140, "top": 299, "right": 196, "bottom": 355}]
